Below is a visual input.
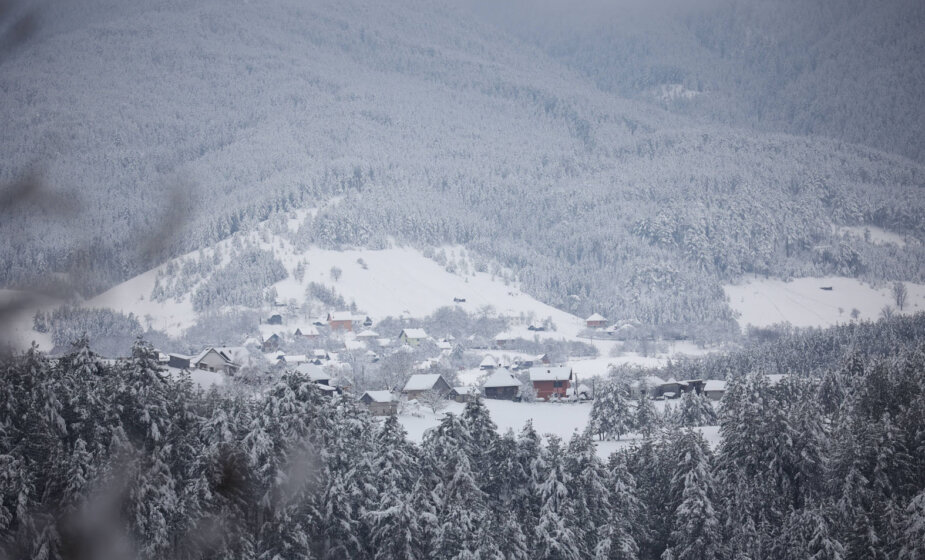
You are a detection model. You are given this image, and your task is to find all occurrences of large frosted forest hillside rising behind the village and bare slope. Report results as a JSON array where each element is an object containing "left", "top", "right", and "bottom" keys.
[{"left": 0, "top": 0, "right": 925, "bottom": 329}]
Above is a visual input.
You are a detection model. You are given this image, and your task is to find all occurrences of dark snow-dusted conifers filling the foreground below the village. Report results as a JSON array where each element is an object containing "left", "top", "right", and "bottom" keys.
[{"left": 0, "top": 312, "right": 925, "bottom": 560}]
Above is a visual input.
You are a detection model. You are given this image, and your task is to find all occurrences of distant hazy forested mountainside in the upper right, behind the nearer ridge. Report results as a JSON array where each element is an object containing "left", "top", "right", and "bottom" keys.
[{"left": 474, "top": 0, "right": 925, "bottom": 162}]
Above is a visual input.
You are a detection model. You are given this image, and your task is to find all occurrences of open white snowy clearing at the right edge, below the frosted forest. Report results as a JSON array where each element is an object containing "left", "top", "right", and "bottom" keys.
[{"left": 723, "top": 277, "right": 925, "bottom": 328}]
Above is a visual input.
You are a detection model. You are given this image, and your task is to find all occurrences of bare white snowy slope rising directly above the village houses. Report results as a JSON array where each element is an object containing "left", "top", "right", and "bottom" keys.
[{"left": 86, "top": 210, "right": 583, "bottom": 338}]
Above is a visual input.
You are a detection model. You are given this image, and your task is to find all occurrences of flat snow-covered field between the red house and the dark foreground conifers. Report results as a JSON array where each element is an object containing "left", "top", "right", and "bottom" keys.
[{"left": 399, "top": 399, "right": 719, "bottom": 457}]
